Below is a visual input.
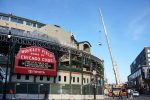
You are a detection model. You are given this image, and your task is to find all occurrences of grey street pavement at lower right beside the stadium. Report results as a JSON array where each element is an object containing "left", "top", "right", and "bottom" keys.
[{"left": 104, "top": 95, "right": 150, "bottom": 100}]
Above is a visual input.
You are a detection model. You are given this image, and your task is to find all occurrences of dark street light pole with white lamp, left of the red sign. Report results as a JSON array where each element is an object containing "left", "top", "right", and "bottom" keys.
[{"left": 2, "top": 30, "right": 11, "bottom": 100}]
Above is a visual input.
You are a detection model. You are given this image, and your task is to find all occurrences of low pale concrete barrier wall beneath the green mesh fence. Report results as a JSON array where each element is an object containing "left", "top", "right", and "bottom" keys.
[{"left": 3, "top": 94, "right": 104, "bottom": 100}]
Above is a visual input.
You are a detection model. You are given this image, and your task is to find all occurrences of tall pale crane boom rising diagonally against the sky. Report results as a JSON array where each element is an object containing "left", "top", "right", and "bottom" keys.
[{"left": 99, "top": 9, "right": 121, "bottom": 85}]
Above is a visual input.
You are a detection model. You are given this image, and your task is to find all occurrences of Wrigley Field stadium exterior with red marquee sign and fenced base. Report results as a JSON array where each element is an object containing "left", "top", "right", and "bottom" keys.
[{"left": 0, "top": 13, "right": 104, "bottom": 100}]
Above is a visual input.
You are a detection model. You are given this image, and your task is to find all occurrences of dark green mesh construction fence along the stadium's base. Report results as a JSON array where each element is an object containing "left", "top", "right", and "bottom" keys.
[{"left": 0, "top": 83, "right": 103, "bottom": 95}]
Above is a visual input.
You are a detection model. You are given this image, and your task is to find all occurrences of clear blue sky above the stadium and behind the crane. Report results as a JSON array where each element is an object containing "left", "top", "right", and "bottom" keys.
[{"left": 0, "top": 0, "right": 150, "bottom": 83}]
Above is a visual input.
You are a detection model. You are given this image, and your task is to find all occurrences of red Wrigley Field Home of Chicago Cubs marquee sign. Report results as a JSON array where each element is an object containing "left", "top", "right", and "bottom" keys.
[{"left": 14, "top": 46, "right": 56, "bottom": 76}]
